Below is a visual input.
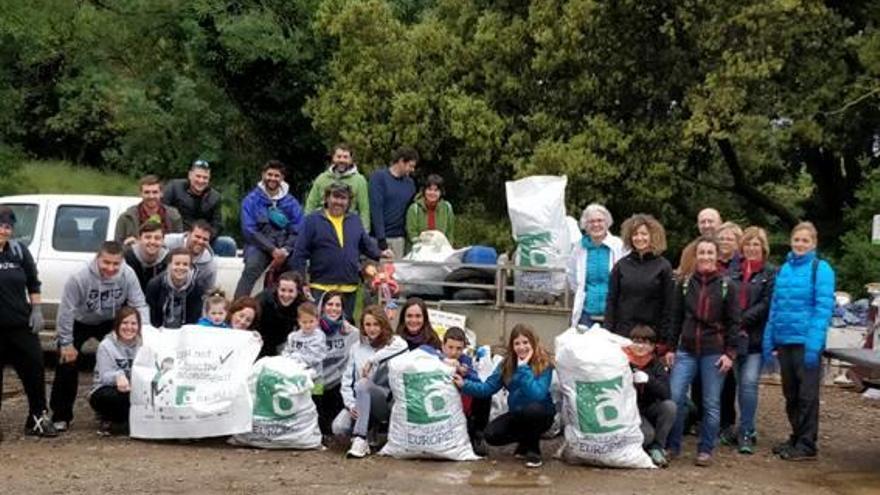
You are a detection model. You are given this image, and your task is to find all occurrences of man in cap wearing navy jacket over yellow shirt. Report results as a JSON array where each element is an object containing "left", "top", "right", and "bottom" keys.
[{"left": 293, "top": 182, "right": 394, "bottom": 321}]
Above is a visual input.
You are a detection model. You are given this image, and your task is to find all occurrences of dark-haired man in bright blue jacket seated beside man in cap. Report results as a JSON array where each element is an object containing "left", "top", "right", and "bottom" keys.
[{"left": 235, "top": 160, "right": 303, "bottom": 297}]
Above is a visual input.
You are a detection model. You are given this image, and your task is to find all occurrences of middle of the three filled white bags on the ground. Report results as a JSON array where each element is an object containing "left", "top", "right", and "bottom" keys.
[{"left": 380, "top": 349, "right": 479, "bottom": 461}]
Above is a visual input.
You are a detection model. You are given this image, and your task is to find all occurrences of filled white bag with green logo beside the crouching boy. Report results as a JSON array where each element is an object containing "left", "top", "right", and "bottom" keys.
[{"left": 556, "top": 325, "right": 655, "bottom": 468}]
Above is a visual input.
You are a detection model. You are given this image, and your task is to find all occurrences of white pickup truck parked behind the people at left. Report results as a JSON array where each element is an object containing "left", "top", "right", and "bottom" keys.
[{"left": 0, "top": 194, "right": 248, "bottom": 344}]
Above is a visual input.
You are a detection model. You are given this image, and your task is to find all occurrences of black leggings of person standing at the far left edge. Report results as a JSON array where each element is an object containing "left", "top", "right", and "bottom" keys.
[{"left": 0, "top": 328, "right": 46, "bottom": 427}]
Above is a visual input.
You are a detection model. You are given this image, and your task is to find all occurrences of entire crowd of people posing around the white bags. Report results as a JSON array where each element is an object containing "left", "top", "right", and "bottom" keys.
[{"left": 0, "top": 153, "right": 834, "bottom": 466}]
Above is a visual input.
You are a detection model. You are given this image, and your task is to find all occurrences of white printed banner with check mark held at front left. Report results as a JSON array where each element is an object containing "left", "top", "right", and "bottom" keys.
[{"left": 129, "top": 325, "right": 260, "bottom": 439}]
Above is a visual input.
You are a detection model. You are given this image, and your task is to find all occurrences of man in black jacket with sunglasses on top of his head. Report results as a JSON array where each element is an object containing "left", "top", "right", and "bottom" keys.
[{"left": 162, "top": 160, "right": 236, "bottom": 256}]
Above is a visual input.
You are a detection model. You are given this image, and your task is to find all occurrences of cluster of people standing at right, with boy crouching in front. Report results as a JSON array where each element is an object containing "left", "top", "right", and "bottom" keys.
[{"left": 569, "top": 204, "right": 835, "bottom": 466}]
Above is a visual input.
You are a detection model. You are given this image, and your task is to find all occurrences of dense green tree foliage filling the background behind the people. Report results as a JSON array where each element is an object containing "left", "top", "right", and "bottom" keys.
[{"left": 0, "top": 0, "right": 880, "bottom": 289}]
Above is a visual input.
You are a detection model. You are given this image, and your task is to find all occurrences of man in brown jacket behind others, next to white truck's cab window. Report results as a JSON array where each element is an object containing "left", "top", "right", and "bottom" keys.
[{"left": 113, "top": 175, "right": 183, "bottom": 246}]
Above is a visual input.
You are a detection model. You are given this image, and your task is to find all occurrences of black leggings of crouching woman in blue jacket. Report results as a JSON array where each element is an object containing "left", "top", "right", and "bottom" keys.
[{"left": 486, "top": 402, "right": 554, "bottom": 454}]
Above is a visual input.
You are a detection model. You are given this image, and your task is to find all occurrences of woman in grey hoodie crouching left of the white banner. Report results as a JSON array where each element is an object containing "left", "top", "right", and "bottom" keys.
[{"left": 89, "top": 306, "right": 141, "bottom": 436}]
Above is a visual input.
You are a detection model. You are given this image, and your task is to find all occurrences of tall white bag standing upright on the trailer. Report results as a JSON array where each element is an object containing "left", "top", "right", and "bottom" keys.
[{"left": 505, "top": 175, "right": 571, "bottom": 303}]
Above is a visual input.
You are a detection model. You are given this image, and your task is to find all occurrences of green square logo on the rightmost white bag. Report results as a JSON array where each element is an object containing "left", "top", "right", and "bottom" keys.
[{"left": 577, "top": 376, "right": 624, "bottom": 433}]
